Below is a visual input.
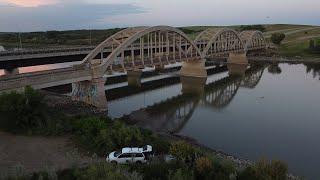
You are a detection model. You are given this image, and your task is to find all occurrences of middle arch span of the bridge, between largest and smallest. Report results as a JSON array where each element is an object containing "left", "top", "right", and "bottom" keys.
[{"left": 195, "top": 28, "right": 245, "bottom": 57}]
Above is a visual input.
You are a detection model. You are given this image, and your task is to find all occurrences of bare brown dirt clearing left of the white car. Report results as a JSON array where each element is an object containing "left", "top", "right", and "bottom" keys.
[{"left": 0, "top": 132, "right": 91, "bottom": 179}]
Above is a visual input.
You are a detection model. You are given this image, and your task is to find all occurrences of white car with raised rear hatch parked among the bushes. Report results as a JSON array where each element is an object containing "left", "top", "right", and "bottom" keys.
[{"left": 106, "top": 145, "right": 152, "bottom": 164}]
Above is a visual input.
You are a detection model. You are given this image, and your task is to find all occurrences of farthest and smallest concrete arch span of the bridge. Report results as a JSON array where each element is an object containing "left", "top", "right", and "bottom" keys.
[{"left": 240, "top": 31, "right": 267, "bottom": 51}]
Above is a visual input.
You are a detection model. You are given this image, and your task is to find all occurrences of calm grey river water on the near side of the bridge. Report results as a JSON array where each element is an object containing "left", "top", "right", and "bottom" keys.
[{"left": 107, "top": 61, "right": 320, "bottom": 179}]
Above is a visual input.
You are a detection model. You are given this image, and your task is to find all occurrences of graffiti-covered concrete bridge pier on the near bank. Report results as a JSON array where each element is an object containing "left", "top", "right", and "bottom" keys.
[{"left": 71, "top": 77, "right": 107, "bottom": 110}]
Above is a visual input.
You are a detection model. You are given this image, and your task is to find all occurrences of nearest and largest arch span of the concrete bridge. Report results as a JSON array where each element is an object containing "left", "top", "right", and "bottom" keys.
[{"left": 82, "top": 26, "right": 201, "bottom": 73}]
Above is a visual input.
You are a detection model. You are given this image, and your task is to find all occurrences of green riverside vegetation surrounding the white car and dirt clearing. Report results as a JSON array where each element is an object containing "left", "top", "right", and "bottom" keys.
[{"left": 0, "top": 87, "right": 288, "bottom": 180}]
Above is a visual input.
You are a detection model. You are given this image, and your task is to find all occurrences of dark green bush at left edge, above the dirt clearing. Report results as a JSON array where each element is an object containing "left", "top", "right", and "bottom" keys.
[{"left": 0, "top": 87, "right": 47, "bottom": 133}]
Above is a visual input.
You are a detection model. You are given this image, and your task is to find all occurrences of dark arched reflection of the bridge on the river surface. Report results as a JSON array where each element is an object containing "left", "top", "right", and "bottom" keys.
[{"left": 120, "top": 65, "right": 266, "bottom": 133}]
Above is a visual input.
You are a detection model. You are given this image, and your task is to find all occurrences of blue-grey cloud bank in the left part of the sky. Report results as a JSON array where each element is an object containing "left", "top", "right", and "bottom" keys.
[{"left": 0, "top": 1, "right": 144, "bottom": 32}]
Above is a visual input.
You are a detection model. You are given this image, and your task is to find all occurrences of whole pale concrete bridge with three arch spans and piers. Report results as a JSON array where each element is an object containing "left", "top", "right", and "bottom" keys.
[{"left": 0, "top": 26, "right": 265, "bottom": 108}]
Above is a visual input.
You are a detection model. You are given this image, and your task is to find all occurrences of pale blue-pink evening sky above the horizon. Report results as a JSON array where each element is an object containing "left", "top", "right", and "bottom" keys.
[{"left": 0, "top": 0, "right": 320, "bottom": 32}]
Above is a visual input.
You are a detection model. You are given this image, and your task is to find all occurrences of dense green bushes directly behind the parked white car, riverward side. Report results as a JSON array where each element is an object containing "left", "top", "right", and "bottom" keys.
[{"left": 70, "top": 117, "right": 169, "bottom": 155}]
